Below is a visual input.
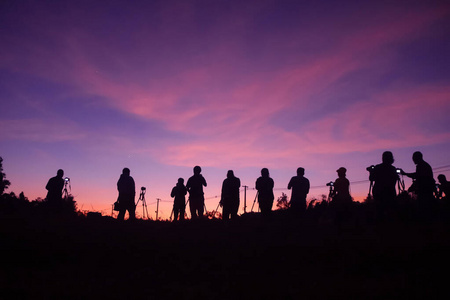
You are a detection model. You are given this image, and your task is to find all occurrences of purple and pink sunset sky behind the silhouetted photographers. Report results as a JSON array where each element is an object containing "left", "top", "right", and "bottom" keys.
[{"left": 0, "top": 0, "right": 450, "bottom": 219}]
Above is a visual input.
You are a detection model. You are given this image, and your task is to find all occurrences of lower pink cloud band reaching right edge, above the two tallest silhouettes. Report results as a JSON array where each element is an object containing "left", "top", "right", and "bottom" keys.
[{"left": 300, "top": 86, "right": 450, "bottom": 153}]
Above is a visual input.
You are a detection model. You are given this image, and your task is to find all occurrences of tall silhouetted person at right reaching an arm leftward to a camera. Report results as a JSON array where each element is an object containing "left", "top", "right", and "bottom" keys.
[{"left": 401, "top": 151, "right": 436, "bottom": 215}]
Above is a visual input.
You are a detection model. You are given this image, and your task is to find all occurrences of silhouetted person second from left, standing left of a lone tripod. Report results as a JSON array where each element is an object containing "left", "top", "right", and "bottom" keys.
[{"left": 117, "top": 168, "right": 136, "bottom": 221}]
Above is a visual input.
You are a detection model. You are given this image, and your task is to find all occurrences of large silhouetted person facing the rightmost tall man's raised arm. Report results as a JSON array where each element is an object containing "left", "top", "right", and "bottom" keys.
[{"left": 368, "top": 151, "right": 399, "bottom": 217}]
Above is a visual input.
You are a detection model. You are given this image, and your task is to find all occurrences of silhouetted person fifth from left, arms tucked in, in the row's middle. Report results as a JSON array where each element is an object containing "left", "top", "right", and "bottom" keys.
[{"left": 220, "top": 170, "right": 241, "bottom": 220}]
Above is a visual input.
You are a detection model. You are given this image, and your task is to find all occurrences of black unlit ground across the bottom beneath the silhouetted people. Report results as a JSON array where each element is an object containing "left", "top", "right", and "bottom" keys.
[{"left": 0, "top": 209, "right": 450, "bottom": 299}]
